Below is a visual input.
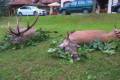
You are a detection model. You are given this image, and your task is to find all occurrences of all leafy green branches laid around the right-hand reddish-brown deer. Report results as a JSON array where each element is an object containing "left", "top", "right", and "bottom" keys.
[{"left": 48, "top": 40, "right": 120, "bottom": 61}]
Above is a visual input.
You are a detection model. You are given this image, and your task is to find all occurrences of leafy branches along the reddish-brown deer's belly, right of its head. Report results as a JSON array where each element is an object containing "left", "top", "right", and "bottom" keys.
[{"left": 79, "top": 40, "right": 120, "bottom": 55}]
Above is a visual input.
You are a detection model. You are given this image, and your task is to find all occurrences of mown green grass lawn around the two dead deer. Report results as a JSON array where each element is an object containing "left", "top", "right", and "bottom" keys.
[{"left": 0, "top": 14, "right": 120, "bottom": 80}]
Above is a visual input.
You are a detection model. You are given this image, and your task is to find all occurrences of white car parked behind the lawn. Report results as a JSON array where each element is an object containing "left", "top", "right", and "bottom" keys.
[{"left": 17, "top": 6, "right": 47, "bottom": 16}]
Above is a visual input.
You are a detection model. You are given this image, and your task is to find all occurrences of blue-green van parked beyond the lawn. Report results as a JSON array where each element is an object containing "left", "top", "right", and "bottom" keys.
[{"left": 60, "top": 0, "right": 94, "bottom": 14}]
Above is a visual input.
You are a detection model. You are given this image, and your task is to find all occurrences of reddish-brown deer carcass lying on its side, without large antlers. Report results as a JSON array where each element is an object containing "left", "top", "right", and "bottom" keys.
[{"left": 59, "top": 29, "right": 120, "bottom": 60}]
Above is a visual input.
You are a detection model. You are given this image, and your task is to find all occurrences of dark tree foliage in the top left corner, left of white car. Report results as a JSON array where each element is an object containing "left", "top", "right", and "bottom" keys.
[{"left": 0, "top": 0, "right": 9, "bottom": 16}]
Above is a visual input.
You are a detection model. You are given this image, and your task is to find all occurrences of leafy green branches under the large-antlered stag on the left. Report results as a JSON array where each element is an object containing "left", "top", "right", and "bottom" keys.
[{"left": 0, "top": 29, "right": 49, "bottom": 51}]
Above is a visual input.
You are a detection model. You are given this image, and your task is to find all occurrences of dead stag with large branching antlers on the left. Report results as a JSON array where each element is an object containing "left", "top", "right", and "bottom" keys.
[{"left": 8, "top": 16, "right": 39, "bottom": 44}]
